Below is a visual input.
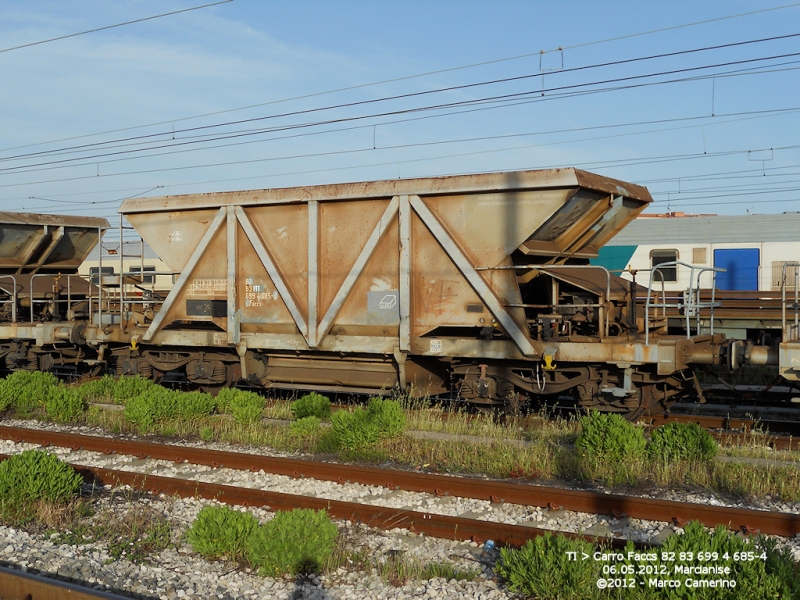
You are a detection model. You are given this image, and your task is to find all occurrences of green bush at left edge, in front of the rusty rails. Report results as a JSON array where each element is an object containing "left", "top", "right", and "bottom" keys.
[{"left": 0, "top": 450, "right": 81, "bottom": 519}]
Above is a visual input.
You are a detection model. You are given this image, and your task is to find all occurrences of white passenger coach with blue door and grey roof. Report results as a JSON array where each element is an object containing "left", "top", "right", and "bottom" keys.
[{"left": 591, "top": 212, "right": 800, "bottom": 343}]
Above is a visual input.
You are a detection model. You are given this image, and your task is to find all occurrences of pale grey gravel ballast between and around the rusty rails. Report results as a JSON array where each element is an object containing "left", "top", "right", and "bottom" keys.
[{"left": 0, "top": 421, "right": 800, "bottom": 599}]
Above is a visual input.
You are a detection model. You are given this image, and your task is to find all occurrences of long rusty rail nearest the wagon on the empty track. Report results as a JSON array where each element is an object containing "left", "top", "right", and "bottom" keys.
[{"left": 0, "top": 426, "right": 800, "bottom": 537}]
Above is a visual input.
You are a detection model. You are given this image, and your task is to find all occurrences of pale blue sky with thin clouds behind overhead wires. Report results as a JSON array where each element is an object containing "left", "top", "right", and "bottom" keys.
[{"left": 0, "top": 0, "right": 800, "bottom": 218}]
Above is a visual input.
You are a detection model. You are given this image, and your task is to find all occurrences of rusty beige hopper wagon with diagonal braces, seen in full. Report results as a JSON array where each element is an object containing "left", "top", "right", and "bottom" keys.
[{"left": 0, "top": 169, "right": 775, "bottom": 418}]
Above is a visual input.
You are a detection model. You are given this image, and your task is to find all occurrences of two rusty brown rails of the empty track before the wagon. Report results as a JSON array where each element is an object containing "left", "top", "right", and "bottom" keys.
[{"left": 0, "top": 427, "right": 800, "bottom": 545}]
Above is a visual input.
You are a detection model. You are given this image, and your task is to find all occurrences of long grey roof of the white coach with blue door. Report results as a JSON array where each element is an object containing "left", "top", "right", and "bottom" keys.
[{"left": 606, "top": 213, "right": 800, "bottom": 246}]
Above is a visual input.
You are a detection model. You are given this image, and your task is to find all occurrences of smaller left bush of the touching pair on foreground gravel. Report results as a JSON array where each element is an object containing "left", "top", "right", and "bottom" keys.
[{"left": 186, "top": 506, "right": 258, "bottom": 562}]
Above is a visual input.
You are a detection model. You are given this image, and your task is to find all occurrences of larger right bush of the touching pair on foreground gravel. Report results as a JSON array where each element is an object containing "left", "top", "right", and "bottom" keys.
[{"left": 247, "top": 508, "right": 339, "bottom": 577}]
